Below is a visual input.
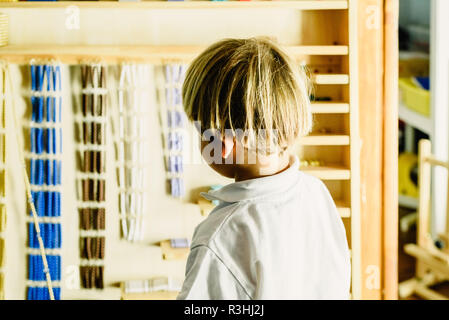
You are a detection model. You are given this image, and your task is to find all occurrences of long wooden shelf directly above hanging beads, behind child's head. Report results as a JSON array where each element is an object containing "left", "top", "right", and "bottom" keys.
[{"left": 0, "top": 44, "right": 348, "bottom": 64}]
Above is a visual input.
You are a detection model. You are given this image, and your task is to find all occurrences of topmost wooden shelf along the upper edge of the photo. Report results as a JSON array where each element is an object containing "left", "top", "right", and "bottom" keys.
[{"left": 0, "top": 0, "right": 348, "bottom": 10}]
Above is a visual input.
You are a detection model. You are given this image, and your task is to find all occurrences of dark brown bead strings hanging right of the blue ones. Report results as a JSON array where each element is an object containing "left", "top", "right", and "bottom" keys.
[{"left": 79, "top": 64, "right": 108, "bottom": 289}]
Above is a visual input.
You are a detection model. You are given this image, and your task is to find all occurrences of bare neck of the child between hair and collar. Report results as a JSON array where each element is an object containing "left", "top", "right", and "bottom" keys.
[{"left": 234, "top": 152, "right": 290, "bottom": 182}]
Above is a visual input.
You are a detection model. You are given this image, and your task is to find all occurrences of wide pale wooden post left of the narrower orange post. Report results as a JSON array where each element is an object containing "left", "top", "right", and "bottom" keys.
[{"left": 357, "top": 0, "right": 384, "bottom": 300}]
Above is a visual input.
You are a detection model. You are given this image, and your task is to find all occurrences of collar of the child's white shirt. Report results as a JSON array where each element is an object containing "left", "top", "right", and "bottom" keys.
[{"left": 201, "top": 155, "right": 300, "bottom": 202}]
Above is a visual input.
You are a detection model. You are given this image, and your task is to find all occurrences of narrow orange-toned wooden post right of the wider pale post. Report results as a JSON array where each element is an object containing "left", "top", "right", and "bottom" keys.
[{"left": 383, "top": 0, "right": 399, "bottom": 299}]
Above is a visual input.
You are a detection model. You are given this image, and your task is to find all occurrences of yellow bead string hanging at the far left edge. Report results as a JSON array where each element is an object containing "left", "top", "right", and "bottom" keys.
[{"left": 0, "top": 65, "right": 6, "bottom": 300}]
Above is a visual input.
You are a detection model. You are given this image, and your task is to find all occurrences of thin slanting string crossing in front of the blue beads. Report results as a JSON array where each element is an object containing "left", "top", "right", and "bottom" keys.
[{"left": 6, "top": 66, "right": 55, "bottom": 300}]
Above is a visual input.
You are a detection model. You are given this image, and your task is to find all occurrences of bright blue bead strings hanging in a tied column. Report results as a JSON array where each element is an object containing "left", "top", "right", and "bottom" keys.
[{"left": 27, "top": 63, "right": 62, "bottom": 300}]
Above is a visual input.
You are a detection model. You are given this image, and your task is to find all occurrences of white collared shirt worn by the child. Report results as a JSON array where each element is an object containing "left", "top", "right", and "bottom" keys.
[{"left": 177, "top": 157, "right": 351, "bottom": 299}]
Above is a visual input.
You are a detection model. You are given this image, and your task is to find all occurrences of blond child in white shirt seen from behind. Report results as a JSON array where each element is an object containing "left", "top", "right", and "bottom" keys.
[{"left": 178, "top": 38, "right": 350, "bottom": 299}]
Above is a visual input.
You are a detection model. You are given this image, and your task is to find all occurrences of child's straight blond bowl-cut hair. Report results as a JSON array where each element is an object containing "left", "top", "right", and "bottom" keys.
[{"left": 182, "top": 38, "right": 312, "bottom": 150}]
